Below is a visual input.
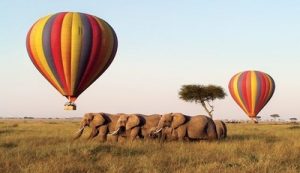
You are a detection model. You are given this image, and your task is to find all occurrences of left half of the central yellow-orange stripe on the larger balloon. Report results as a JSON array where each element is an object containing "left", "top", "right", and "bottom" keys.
[{"left": 61, "top": 13, "right": 73, "bottom": 95}]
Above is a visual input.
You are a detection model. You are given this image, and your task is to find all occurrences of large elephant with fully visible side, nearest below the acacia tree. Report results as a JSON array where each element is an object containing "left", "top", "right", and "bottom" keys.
[{"left": 154, "top": 113, "right": 218, "bottom": 141}]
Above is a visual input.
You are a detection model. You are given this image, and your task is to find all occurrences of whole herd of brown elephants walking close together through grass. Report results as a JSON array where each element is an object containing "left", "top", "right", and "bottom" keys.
[{"left": 74, "top": 113, "right": 227, "bottom": 142}]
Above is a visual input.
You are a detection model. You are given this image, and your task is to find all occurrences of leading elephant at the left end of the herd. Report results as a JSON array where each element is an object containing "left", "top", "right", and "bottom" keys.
[{"left": 74, "top": 112, "right": 120, "bottom": 141}]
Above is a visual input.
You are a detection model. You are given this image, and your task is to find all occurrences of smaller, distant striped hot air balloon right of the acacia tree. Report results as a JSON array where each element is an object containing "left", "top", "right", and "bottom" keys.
[{"left": 228, "top": 71, "right": 275, "bottom": 120}]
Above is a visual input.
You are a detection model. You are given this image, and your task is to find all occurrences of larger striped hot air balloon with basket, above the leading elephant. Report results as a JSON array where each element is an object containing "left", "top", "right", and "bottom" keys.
[{"left": 26, "top": 12, "right": 118, "bottom": 110}]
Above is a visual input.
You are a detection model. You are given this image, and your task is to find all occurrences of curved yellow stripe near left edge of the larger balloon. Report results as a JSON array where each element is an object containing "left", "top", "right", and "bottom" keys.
[{"left": 30, "top": 15, "right": 65, "bottom": 95}]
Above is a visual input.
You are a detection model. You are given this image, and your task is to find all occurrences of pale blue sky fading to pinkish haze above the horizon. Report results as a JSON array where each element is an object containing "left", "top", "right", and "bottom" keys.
[{"left": 0, "top": 0, "right": 300, "bottom": 119}]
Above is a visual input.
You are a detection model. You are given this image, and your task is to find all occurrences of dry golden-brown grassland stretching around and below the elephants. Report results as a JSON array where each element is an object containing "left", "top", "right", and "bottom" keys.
[{"left": 0, "top": 120, "right": 300, "bottom": 173}]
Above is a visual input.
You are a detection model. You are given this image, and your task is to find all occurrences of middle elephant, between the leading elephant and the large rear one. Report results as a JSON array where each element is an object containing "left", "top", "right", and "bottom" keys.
[{"left": 111, "top": 114, "right": 161, "bottom": 141}]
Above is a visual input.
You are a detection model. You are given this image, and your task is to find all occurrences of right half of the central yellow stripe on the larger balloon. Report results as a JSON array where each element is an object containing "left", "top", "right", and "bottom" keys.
[{"left": 71, "top": 13, "right": 82, "bottom": 95}]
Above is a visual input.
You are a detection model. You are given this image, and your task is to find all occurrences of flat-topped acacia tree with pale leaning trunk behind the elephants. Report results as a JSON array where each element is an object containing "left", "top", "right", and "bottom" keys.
[{"left": 178, "top": 85, "right": 226, "bottom": 118}]
